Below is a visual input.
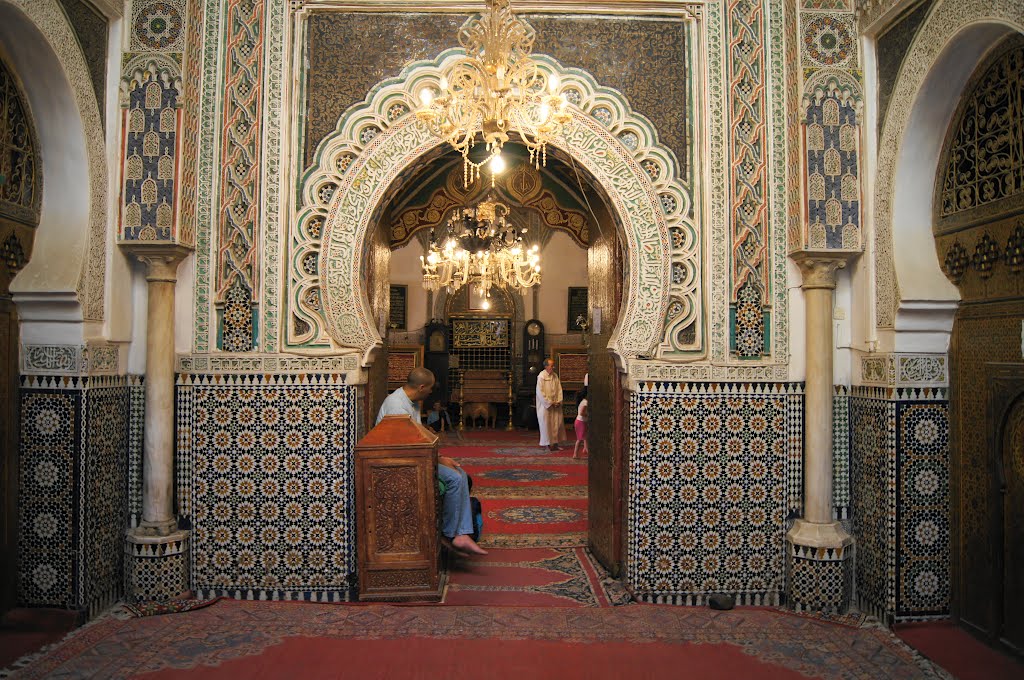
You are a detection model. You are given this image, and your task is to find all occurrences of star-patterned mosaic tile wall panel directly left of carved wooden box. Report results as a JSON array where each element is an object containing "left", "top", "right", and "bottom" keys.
[{"left": 177, "top": 375, "right": 355, "bottom": 600}]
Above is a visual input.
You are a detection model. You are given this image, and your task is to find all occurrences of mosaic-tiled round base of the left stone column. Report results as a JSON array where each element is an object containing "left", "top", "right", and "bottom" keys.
[{"left": 125, "top": 528, "right": 188, "bottom": 602}]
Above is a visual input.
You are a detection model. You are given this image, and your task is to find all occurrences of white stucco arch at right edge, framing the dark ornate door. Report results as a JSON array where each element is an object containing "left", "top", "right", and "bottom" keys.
[{"left": 874, "top": 0, "right": 1024, "bottom": 335}]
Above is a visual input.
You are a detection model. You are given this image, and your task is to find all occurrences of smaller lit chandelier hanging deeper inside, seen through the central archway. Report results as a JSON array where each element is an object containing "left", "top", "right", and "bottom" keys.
[{"left": 420, "top": 191, "right": 541, "bottom": 298}]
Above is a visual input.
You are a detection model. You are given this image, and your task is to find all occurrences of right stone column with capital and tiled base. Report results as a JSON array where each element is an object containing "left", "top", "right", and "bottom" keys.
[{"left": 785, "top": 252, "right": 853, "bottom": 613}]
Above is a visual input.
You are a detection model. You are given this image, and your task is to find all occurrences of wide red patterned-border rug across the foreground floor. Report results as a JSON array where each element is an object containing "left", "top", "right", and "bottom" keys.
[{"left": 9, "top": 600, "right": 936, "bottom": 680}]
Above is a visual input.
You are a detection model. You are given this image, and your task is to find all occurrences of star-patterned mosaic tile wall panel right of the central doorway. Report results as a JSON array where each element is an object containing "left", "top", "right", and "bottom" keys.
[{"left": 627, "top": 382, "right": 801, "bottom": 604}]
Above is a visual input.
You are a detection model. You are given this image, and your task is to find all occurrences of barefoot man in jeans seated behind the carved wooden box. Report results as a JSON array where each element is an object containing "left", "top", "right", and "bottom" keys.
[{"left": 375, "top": 368, "right": 487, "bottom": 555}]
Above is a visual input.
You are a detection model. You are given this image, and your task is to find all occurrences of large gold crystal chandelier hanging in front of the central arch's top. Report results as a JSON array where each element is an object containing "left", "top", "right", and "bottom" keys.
[{"left": 416, "top": 0, "right": 569, "bottom": 186}]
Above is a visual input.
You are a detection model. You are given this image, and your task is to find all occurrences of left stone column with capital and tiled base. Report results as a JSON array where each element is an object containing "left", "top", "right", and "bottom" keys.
[{"left": 125, "top": 243, "right": 189, "bottom": 600}]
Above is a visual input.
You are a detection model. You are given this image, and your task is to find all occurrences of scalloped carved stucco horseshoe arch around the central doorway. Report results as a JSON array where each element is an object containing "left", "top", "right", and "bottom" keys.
[{"left": 299, "top": 50, "right": 703, "bottom": 370}]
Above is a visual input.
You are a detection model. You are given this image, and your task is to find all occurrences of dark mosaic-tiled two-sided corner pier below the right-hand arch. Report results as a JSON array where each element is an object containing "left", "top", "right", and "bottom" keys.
[{"left": 850, "top": 387, "right": 950, "bottom": 621}]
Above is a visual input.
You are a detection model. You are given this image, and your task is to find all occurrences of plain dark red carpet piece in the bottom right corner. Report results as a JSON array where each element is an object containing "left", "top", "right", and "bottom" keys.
[{"left": 893, "top": 621, "right": 1024, "bottom": 680}]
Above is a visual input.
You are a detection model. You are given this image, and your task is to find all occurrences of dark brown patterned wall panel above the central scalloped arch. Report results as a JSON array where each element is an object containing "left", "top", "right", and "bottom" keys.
[{"left": 304, "top": 12, "right": 693, "bottom": 176}]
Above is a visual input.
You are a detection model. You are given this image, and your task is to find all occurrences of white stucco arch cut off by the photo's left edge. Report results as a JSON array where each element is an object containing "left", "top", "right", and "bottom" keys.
[{"left": 0, "top": 0, "right": 108, "bottom": 322}]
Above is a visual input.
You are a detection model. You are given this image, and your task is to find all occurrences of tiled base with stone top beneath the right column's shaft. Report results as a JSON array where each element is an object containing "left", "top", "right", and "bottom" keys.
[{"left": 785, "top": 519, "right": 854, "bottom": 614}]
